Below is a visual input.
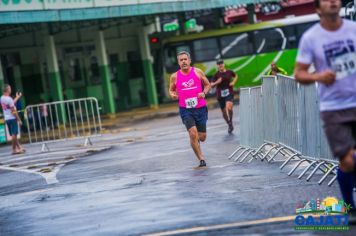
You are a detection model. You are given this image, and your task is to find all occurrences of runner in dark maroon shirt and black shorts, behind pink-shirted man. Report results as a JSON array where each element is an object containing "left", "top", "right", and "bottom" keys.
[{"left": 211, "top": 59, "right": 238, "bottom": 134}]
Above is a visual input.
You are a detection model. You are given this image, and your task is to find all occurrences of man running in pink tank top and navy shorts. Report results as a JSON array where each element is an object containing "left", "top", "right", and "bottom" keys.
[{"left": 169, "top": 51, "right": 211, "bottom": 167}]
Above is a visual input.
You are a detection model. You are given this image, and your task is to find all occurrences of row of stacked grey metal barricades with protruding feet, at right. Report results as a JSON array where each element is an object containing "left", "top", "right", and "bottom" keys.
[{"left": 229, "top": 75, "right": 337, "bottom": 185}]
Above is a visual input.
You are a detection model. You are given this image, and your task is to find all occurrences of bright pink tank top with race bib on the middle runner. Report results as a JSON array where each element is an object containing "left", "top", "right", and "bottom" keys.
[{"left": 176, "top": 67, "right": 206, "bottom": 108}]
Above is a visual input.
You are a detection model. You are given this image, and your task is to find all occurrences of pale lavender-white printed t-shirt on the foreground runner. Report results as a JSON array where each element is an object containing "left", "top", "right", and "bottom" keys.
[{"left": 297, "top": 19, "right": 356, "bottom": 111}]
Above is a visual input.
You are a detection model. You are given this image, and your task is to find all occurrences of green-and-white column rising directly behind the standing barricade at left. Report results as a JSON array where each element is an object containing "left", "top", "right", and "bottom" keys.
[{"left": 44, "top": 35, "right": 63, "bottom": 101}]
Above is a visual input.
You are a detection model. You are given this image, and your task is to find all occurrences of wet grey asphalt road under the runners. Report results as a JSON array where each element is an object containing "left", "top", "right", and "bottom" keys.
[{"left": 0, "top": 109, "right": 354, "bottom": 235}]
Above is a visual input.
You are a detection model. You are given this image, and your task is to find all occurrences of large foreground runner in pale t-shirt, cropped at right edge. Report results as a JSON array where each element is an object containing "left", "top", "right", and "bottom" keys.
[{"left": 295, "top": 0, "right": 356, "bottom": 222}]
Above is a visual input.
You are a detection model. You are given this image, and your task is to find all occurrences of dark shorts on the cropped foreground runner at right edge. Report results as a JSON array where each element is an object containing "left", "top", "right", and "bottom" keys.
[{"left": 320, "top": 108, "right": 356, "bottom": 159}]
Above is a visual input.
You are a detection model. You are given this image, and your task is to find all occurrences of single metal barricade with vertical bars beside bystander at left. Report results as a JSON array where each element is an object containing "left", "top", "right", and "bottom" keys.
[{"left": 25, "top": 97, "right": 101, "bottom": 151}]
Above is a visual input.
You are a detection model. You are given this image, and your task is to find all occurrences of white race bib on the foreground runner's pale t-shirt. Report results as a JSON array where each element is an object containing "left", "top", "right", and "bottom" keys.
[{"left": 331, "top": 52, "right": 356, "bottom": 80}]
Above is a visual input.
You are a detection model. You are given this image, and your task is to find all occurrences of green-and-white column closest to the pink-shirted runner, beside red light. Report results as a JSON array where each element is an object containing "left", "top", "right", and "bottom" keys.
[{"left": 138, "top": 27, "right": 158, "bottom": 108}]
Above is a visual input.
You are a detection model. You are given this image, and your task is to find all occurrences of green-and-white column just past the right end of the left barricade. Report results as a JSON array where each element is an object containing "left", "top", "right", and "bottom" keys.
[{"left": 95, "top": 30, "right": 116, "bottom": 115}]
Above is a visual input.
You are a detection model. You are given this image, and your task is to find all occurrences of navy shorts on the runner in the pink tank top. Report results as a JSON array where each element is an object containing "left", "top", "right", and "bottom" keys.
[{"left": 179, "top": 106, "right": 208, "bottom": 133}]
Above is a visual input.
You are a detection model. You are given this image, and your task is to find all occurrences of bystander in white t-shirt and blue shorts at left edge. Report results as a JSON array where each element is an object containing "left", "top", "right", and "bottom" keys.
[{"left": 0, "top": 84, "right": 25, "bottom": 154}]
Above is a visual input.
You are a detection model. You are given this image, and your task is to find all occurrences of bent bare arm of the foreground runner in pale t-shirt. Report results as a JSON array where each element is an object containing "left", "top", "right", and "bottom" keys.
[{"left": 294, "top": 62, "right": 336, "bottom": 85}]
